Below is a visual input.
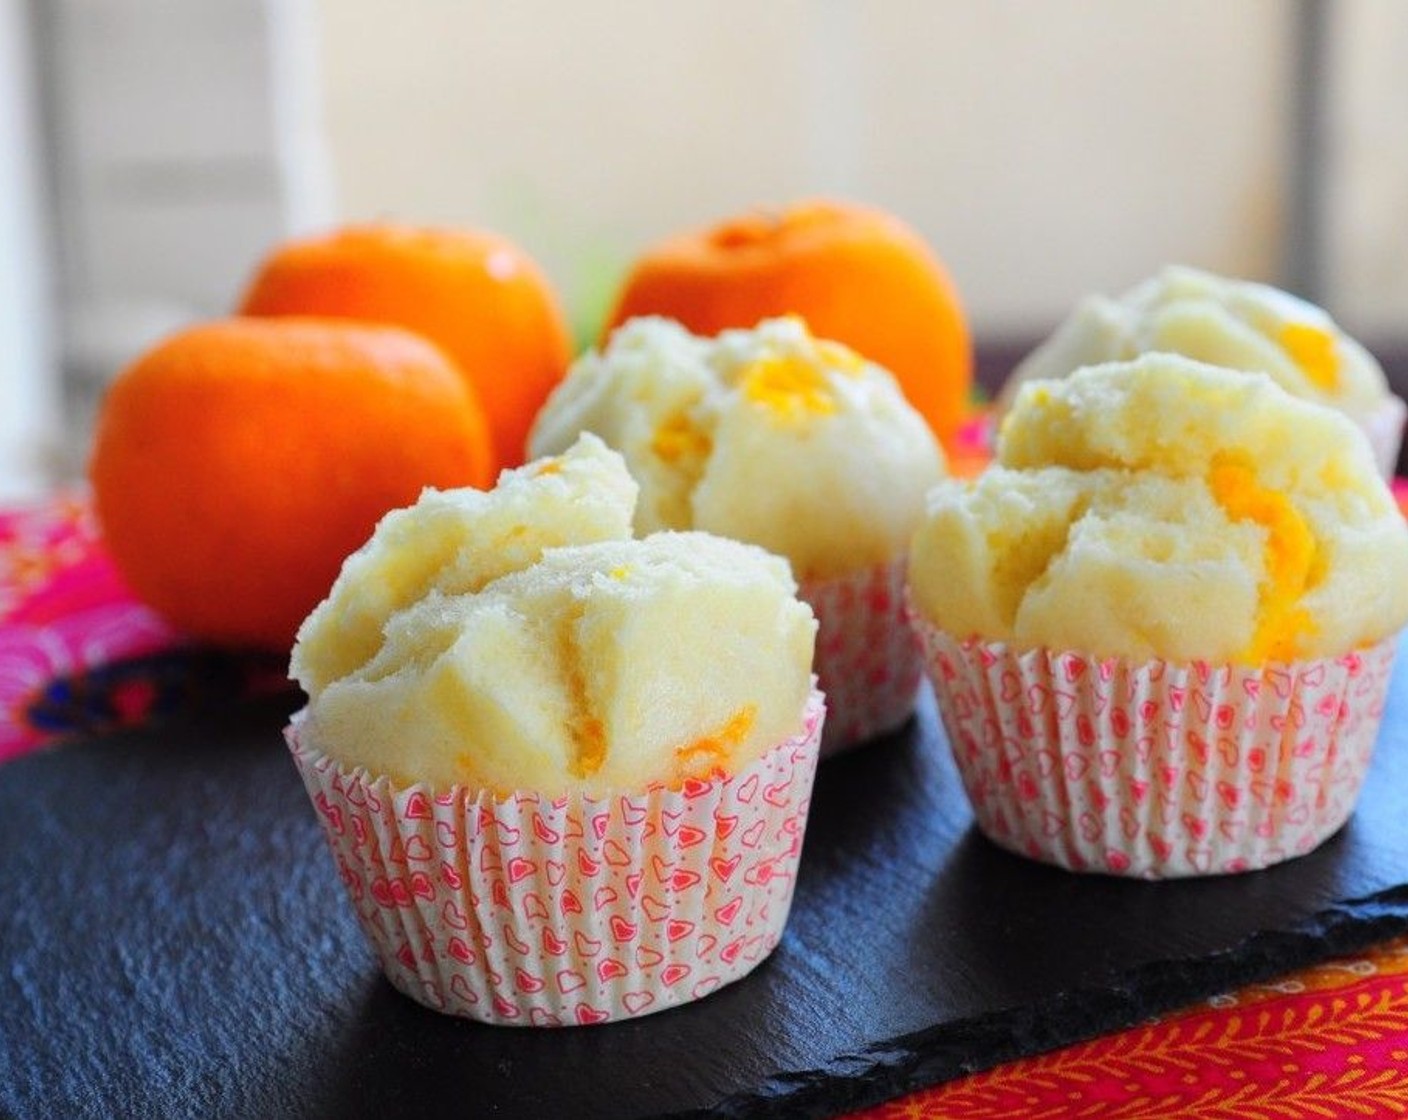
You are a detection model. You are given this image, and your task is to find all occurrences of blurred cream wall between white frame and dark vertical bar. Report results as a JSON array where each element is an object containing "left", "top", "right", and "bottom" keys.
[{"left": 320, "top": 0, "right": 1290, "bottom": 334}]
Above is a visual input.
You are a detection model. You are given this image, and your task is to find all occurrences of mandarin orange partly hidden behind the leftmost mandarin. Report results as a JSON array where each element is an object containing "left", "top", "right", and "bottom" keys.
[{"left": 239, "top": 224, "right": 572, "bottom": 471}]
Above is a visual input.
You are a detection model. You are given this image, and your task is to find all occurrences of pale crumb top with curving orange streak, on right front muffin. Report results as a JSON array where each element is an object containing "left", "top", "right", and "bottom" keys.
[{"left": 910, "top": 354, "right": 1408, "bottom": 664}]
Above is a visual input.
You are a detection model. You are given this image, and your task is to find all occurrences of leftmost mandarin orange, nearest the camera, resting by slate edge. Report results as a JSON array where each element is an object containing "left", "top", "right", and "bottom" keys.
[{"left": 89, "top": 318, "right": 493, "bottom": 649}]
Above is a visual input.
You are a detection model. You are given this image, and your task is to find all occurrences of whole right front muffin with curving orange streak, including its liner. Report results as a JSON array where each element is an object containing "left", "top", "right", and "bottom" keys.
[{"left": 910, "top": 354, "right": 1408, "bottom": 875}]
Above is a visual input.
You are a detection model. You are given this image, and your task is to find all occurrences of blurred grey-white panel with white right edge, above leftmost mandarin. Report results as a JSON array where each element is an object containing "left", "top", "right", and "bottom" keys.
[{"left": 42, "top": 0, "right": 331, "bottom": 475}]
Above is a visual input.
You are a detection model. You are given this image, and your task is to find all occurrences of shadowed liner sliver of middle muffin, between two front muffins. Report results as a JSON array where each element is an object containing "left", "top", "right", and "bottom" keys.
[{"left": 798, "top": 558, "right": 924, "bottom": 758}]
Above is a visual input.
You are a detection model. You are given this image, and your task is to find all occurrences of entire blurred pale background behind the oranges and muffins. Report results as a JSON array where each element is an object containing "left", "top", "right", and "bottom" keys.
[{"left": 0, "top": 0, "right": 1408, "bottom": 500}]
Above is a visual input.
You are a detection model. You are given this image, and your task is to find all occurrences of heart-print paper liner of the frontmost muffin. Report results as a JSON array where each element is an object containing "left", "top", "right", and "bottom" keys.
[{"left": 286, "top": 692, "right": 825, "bottom": 1026}]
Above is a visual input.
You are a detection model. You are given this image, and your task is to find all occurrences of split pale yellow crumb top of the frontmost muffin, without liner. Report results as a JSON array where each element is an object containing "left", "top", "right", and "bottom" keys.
[{"left": 293, "top": 437, "right": 817, "bottom": 796}]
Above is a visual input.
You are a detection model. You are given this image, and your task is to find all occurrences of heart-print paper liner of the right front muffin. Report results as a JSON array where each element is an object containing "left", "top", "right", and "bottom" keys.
[{"left": 917, "top": 620, "right": 1397, "bottom": 879}]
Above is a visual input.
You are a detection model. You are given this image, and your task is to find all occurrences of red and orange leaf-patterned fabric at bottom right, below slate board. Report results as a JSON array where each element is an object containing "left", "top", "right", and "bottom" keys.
[{"left": 853, "top": 938, "right": 1408, "bottom": 1120}]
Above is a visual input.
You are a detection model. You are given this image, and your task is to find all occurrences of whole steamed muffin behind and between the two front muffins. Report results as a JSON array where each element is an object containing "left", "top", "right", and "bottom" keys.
[{"left": 529, "top": 317, "right": 943, "bottom": 747}]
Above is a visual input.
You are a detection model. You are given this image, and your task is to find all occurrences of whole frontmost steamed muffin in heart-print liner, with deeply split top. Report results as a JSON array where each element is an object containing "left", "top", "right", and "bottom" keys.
[{"left": 289, "top": 435, "right": 822, "bottom": 1026}]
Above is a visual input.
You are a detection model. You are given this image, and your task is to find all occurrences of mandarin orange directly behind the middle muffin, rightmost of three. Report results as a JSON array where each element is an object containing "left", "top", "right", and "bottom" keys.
[{"left": 607, "top": 200, "right": 973, "bottom": 448}]
